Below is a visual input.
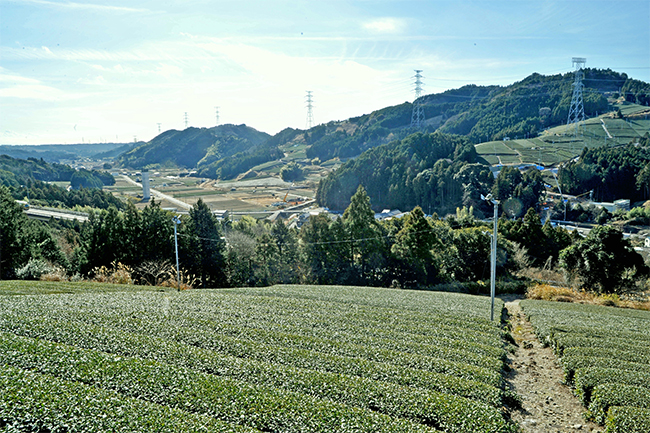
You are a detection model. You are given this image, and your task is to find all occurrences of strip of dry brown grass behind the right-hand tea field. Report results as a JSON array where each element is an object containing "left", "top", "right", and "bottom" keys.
[{"left": 526, "top": 284, "right": 650, "bottom": 311}]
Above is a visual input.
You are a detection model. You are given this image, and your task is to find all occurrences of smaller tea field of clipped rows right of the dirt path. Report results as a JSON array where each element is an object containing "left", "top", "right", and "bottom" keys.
[{"left": 520, "top": 300, "right": 650, "bottom": 433}]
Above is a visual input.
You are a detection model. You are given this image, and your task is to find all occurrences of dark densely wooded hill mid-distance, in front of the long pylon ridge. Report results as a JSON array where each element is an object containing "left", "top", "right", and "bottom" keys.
[{"left": 316, "top": 133, "right": 480, "bottom": 213}]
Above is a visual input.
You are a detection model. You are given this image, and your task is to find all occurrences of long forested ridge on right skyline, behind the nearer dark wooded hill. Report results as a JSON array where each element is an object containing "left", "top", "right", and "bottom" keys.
[{"left": 279, "top": 69, "right": 650, "bottom": 161}]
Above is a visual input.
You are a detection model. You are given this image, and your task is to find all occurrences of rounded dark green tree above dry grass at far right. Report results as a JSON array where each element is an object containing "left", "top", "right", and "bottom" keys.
[{"left": 560, "top": 226, "right": 648, "bottom": 293}]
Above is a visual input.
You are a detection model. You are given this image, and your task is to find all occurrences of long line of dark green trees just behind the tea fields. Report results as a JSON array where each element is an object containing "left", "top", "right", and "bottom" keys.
[{"left": 0, "top": 187, "right": 647, "bottom": 291}]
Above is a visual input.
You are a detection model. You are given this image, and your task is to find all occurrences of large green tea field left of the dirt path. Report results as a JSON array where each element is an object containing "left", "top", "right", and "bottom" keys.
[{"left": 0, "top": 283, "right": 516, "bottom": 432}]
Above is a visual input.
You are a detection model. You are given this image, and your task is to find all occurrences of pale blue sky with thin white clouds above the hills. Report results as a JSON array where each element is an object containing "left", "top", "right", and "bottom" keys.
[{"left": 0, "top": 0, "right": 650, "bottom": 144}]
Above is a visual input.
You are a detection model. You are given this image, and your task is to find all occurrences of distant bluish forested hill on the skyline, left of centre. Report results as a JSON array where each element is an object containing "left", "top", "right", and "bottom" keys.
[{"left": 117, "top": 125, "right": 271, "bottom": 168}]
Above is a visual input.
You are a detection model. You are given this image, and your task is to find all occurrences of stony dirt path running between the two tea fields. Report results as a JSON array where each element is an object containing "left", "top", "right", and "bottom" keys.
[{"left": 506, "top": 299, "right": 604, "bottom": 433}]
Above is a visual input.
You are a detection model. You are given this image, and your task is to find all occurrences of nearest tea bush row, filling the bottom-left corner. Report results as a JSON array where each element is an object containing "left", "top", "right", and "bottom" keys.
[{"left": 0, "top": 366, "right": 248, "bottom": 433}]
